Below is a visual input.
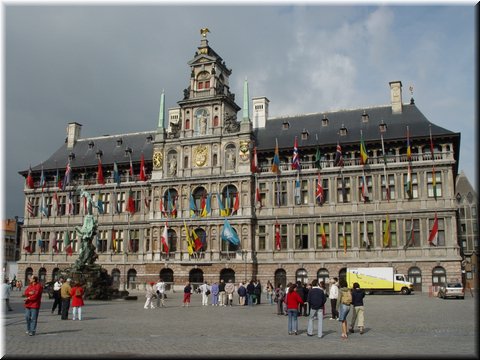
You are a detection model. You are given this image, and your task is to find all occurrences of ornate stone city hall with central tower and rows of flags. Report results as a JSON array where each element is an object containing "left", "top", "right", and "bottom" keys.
[{"left": 17, "top": 32, "right": 461, "bottom": 292}]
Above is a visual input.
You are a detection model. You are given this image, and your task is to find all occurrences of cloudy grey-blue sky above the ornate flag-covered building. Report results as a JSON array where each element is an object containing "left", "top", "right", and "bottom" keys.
[{"left": 2, "top": 3, "right": 477, "bottom": 218}]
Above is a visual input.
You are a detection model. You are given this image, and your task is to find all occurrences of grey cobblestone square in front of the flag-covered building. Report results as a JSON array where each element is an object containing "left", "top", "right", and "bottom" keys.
[{"left": 2, "top": 292, "right": 478, "bottom": 358}]
